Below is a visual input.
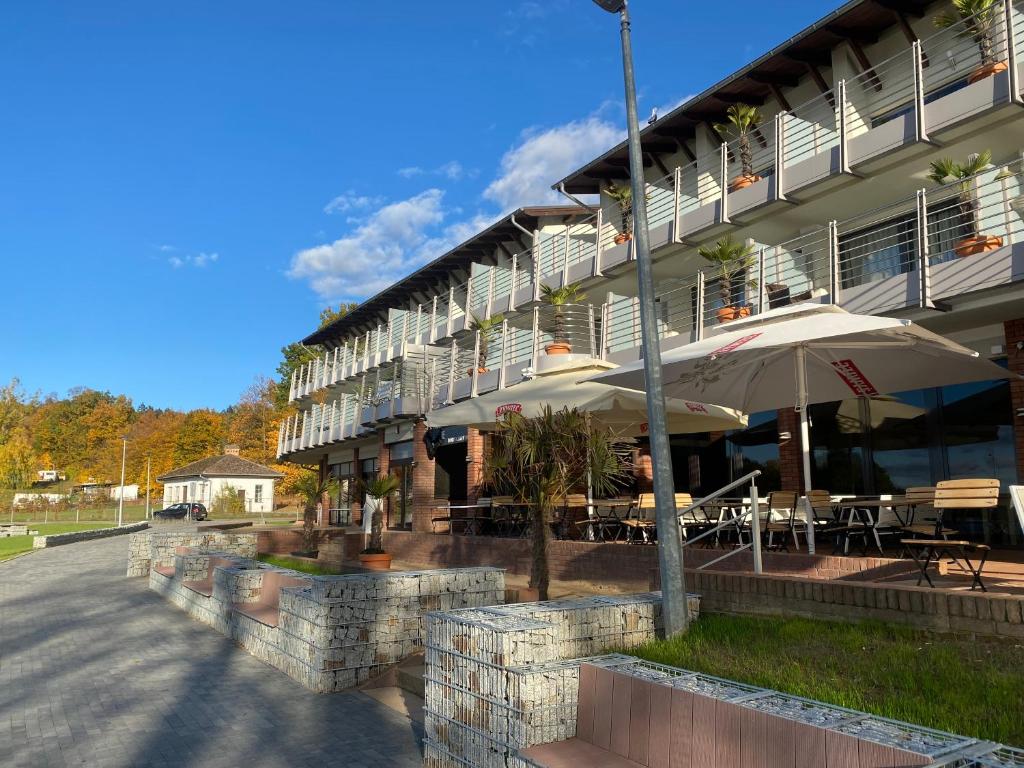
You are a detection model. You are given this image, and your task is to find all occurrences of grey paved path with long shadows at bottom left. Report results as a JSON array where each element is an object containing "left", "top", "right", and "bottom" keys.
[{"left": 0, "top": 537, "right": 422, "bottom": 768}]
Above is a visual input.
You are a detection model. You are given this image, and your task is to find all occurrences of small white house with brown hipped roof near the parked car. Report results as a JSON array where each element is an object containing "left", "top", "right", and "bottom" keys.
[{"left": 157, "top": 445, "right": 284, "bottom": 513}]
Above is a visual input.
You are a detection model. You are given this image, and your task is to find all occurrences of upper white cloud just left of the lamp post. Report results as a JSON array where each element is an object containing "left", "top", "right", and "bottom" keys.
[{"left": 483, "top": 115, "right": 625, "bottom": 211}]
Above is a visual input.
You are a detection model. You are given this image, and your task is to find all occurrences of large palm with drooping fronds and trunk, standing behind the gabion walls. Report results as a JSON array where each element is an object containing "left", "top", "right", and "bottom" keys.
[{"left": 484, "top": 406, "right": 631, "bottom": 600}]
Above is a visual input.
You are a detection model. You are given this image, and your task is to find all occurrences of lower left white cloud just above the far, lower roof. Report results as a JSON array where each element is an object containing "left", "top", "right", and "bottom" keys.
[{"left": 288, "top": 188, "right": 449, "bottom": 300}]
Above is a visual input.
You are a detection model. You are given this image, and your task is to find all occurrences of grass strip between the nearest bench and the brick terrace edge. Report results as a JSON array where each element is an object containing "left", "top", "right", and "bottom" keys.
[{"left": 625, "top": 615, "right": 1024, "bottom": 745}]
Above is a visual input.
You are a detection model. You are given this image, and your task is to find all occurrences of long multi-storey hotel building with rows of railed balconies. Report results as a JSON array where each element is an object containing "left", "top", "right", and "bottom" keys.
[{"left": 279, "top": 0, "right": 1024, "bottom": 545}]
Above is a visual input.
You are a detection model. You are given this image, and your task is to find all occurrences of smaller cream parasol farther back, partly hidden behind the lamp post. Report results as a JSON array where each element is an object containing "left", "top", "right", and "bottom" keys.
[{"left": 427, "top": 360, "right": 746, "bottom": 437}]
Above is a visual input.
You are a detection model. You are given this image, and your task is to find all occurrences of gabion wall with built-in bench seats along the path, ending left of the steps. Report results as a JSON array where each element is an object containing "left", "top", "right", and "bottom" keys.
[{"left": 150, "top": 535, "right": 505, "bottom": 692}]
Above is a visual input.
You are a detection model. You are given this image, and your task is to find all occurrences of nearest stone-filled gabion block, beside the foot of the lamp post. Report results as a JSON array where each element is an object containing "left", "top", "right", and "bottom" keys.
[{"left": 424, "top": 592, "right": 699, "bottom": 766}]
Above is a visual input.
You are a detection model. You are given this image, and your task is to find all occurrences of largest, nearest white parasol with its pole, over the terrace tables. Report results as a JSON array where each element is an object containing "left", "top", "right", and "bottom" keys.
[{"left": 590, "top": 304, "right": 1012, "bottom": 551}]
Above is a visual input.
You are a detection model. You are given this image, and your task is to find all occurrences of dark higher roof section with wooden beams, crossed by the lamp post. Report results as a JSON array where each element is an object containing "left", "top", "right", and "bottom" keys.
[{"left": 553, "top": 0, "right": 933, "bottom": 195}]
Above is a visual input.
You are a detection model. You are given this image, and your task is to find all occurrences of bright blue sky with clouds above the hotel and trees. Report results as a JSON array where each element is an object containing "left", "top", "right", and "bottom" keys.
[{"left": 0, "top": 0, "right": 834, "bottom": 409}]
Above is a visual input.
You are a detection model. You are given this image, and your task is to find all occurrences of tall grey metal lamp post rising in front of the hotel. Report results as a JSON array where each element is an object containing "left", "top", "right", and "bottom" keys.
[{"left": 594, "top": 0, "right": 688, "bottom": 637}]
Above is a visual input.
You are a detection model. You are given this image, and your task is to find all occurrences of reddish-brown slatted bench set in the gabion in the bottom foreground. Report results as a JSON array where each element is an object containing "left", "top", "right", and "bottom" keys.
[{"left": 520, "top": 664, "right": 932, "bottom": 768}]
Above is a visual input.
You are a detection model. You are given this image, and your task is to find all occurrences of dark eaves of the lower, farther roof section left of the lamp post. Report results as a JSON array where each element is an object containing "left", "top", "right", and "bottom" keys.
[{"left": 302, "top": 205, "right": 591, "bottom": 344}]
